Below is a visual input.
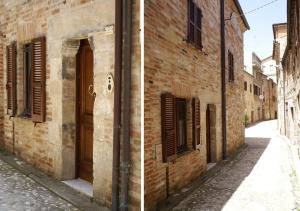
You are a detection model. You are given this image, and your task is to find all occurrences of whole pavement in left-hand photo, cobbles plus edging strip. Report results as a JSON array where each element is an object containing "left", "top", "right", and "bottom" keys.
[{"left": 0, "top": 148, "right": 109, "bottom": 211}]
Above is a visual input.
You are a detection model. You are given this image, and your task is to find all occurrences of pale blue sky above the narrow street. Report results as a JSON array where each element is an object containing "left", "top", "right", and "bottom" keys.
[{"left": 240, "top": 0, "right": 287, "bottom": 67}]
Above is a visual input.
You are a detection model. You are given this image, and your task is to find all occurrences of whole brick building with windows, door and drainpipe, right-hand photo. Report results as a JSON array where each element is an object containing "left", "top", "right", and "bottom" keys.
[{"left": 144, "top": 0, "right": 249, "bottom": 209}]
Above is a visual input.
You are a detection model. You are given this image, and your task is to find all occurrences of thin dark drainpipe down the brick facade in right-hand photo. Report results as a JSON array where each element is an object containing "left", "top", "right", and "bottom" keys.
[{"left": 220, "top": 0, "right": 227, "bottom": 160}]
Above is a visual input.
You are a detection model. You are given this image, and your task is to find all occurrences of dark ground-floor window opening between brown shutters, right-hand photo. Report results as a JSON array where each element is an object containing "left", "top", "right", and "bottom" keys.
[{"left": 176, "top": 98, "right": 187, "bottom": 153}]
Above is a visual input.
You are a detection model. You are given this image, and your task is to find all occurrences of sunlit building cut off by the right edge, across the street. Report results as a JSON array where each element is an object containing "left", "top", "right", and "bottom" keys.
[{"left": 275, "top": 0, "right": 300, "bottom": 149}]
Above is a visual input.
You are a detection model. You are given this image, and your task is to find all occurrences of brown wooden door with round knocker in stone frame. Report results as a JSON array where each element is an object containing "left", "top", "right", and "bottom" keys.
[{"left": 76, "top": 40, "right": 94, "bottom": 182}]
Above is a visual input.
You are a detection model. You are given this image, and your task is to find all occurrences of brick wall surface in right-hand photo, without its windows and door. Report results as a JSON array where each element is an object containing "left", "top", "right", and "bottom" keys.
[{"left": 144, "top": 0, "right": 245, "bottom": 209}]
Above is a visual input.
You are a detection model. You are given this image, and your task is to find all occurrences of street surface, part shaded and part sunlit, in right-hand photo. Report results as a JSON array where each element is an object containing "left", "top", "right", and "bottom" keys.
[{"left": 173, "top": 121, "right": 300, "bottom": 211}]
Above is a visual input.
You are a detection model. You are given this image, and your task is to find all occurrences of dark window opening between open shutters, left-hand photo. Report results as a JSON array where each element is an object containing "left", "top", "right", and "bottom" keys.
[{"left": 22, "top": 44, "right": 32, "bottom": 117}]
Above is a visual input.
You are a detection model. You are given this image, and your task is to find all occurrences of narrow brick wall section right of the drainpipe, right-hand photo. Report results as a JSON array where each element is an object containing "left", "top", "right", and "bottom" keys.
[{"left": 225, "top": 1, "right": 246, "bottom": 154}]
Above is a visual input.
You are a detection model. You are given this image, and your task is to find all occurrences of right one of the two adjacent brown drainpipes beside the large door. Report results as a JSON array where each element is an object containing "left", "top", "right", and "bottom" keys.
[{"left": 120, "top": 0, "right": 132, "bottom": 210}]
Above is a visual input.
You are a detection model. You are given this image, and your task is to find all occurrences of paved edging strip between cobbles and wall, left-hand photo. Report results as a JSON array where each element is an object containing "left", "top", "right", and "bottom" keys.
[{"left": 0, "top": 148, "right": 109, "bottom": 211}]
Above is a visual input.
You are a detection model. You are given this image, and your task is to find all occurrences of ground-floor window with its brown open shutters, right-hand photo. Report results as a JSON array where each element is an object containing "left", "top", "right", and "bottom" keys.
[{"left": 161, "top": 93, "right": 200, "bottom": 162}]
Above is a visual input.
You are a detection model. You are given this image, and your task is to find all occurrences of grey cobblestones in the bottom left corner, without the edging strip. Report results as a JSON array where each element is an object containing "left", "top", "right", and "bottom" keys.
[{"left": 0, "top": 160, "right": 79, "bottom": 211}]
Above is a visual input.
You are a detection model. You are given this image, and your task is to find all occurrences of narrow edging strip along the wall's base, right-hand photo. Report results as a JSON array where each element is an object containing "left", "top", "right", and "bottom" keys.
[{"left": 155, "top": 144, "right": 248, "bottom": 211}]
